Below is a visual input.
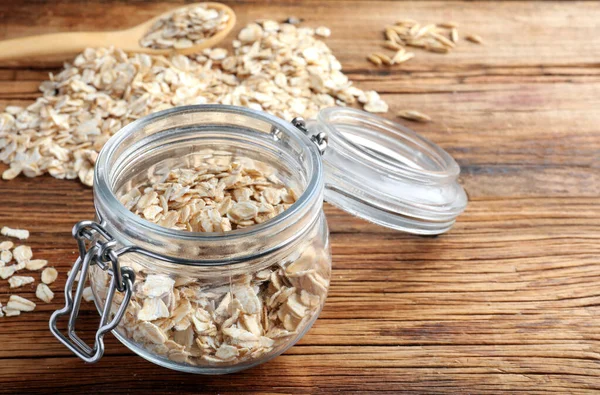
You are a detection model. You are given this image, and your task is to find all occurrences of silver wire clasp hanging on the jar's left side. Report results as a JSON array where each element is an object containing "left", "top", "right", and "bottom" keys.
[{"left": 50, "top": 221, "right": 135, "bottom": 363}]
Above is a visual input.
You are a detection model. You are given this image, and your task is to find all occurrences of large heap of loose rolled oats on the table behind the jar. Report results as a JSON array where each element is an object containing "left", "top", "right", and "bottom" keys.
[{"left": 0, "top": 21, "right": 387, "bottom": 187}]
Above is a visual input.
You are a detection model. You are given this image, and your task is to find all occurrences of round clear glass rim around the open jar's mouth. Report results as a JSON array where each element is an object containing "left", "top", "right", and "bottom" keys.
[{"left": 94, "top": 104, "right": 323, "bottom": 249}]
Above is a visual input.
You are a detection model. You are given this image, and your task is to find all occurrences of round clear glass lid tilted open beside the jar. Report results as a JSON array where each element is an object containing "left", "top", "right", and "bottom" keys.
[{"left": 306, "top": 107, "right": 467, "bottom": 235}]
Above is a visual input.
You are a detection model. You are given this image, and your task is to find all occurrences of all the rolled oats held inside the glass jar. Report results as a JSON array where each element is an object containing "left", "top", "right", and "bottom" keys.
[{"left": 84, "top": 152, "right": 332, "bottom": 372}]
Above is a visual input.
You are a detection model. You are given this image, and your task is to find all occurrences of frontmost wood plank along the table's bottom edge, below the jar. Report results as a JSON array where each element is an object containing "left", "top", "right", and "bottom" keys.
[{"left": 0, "top": 356, "right": 598, "bottom": 393}]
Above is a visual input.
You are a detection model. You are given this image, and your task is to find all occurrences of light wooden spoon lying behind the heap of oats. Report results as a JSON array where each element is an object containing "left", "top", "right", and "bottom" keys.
[{"left": 0, "top": 2, "right": 236, "bottom": 61}]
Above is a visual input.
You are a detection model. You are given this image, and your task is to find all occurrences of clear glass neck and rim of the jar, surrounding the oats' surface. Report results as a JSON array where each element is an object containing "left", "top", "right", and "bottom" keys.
[{"left": 94, "top": 105, "right": 323, "bottom": 266}]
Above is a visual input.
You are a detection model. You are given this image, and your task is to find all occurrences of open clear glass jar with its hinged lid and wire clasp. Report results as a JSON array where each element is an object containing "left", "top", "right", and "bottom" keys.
[{"left": 50, "top": 105, "right": 466, "bottom": 374}]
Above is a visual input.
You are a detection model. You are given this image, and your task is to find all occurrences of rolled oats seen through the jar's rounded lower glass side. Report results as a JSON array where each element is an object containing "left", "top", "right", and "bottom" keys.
[{"left": 99, "top": 243, "right": 329, "bottom": 365}]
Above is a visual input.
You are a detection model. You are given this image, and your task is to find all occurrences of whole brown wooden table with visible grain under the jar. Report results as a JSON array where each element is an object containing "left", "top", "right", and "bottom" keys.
[{"left": 0, "top": 0, "right": 600, "bottom": 394}]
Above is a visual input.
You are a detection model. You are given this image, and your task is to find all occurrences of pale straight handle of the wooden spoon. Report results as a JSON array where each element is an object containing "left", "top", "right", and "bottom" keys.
[{"left": 0, "top": 32, "right": 119, "bottom": 61}]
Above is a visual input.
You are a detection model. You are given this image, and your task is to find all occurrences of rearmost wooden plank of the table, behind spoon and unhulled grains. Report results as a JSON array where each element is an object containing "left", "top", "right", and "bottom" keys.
[{"left": 0, "top": 0, "right": 600, "bottom": 71}]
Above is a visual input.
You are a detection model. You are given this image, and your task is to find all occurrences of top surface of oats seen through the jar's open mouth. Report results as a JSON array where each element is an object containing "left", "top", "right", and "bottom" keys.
[{"left": 125, "top": 152, "right": 296, "bottom": 232}]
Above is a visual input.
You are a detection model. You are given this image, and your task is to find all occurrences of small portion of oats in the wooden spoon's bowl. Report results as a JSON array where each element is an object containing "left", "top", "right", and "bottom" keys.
[{"left": 140, "top": 4, "right": 229, "bottom": 49}]
